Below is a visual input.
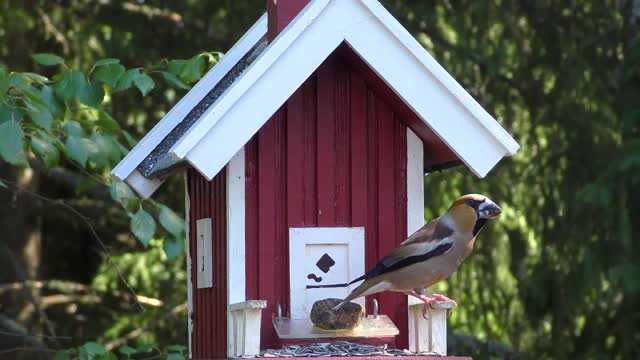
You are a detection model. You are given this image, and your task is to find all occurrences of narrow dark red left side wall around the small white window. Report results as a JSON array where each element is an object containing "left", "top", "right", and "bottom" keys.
[{"left": 187, "top": 168, "right": 227, "bottom": 359}]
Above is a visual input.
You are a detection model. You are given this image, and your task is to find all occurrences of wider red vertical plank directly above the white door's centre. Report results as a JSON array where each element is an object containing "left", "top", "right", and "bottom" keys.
[{"left": 317, "top": 57, "right": 336, "bottom": 226}]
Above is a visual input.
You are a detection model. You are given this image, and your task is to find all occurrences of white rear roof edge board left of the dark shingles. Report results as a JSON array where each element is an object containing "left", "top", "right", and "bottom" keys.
[{"left": 111, "top": 13, "right": 267, "bottom": 183}]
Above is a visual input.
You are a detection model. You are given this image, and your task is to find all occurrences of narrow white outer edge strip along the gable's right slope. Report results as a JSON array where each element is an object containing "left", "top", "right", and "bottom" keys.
[{"left": 360, "top": 0, "right": 520, "bottom": 155}]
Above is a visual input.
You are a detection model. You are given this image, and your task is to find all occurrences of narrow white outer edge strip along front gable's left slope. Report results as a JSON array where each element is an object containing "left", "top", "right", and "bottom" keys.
[{"left": 169, "top": 0, "right": 331, "bottom": 159}]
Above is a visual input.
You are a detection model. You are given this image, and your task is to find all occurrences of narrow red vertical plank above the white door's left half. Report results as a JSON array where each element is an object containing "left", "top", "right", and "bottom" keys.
[{"left": 299, "top": 74, "right": 318, "bottom": 226}]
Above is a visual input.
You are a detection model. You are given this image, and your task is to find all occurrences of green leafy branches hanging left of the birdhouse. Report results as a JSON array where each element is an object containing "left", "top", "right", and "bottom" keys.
[{"left": 0, "top": 53, "right": 217, "bottom": 259}]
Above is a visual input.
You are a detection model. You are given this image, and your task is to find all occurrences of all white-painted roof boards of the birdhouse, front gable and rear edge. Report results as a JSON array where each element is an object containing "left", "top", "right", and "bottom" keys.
[{"left": 112, "top": 0, "right": 519, "bottom": 197}]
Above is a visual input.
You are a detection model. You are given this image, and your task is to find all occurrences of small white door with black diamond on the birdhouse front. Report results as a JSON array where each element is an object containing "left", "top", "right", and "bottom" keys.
[{"left": 289, "top": 227, "right": 365, "bottom": 319}]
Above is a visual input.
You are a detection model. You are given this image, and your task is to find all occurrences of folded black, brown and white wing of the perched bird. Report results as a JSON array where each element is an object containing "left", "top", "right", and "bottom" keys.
[{"left": 352, "top": 218, "right": 454, "bottom": 283}]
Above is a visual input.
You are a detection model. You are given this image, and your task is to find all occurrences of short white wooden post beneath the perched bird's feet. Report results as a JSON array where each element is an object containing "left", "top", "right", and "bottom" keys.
[{"left": 409, "top": 301, "right": 453, "bottom": 355}]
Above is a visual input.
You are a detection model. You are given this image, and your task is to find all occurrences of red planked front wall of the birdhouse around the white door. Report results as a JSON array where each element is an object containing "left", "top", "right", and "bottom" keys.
[{"left": 245, "top": 52, "right": 408, "bottom": 348}]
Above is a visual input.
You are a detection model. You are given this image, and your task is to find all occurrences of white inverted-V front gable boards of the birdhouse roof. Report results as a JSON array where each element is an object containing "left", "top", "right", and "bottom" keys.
[{"left": 170, "top": 0, "right": 519, "bottom": 183}]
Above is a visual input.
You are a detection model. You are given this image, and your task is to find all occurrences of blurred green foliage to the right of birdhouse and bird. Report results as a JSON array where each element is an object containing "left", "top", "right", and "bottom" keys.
[{"left": 387, "top": 1, "right": 640, "bottom": 359}]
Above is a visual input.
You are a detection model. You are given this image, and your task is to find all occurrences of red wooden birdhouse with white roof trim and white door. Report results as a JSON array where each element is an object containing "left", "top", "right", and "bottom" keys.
[{"left": 113, "top": 0, "right": 519, "bottom": 358}]
